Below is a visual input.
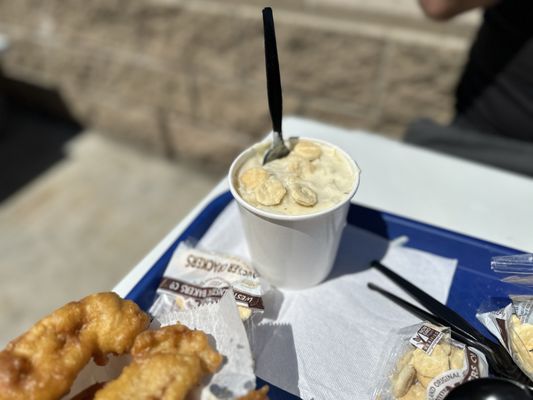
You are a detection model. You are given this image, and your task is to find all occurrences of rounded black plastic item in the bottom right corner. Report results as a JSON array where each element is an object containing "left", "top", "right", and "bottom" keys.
[{"left": 445, "top": 378, "right": 533, "bottom": 400}]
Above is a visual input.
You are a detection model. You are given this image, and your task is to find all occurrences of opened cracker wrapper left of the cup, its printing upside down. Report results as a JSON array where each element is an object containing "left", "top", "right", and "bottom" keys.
[{"left": 149, "top": 242, "right": 264, "bottom": 320}]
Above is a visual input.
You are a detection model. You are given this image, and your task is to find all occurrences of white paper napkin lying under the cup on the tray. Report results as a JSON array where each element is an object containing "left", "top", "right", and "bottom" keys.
[{"left": 198, "top": 202, "right": 457, "bottom": 400}]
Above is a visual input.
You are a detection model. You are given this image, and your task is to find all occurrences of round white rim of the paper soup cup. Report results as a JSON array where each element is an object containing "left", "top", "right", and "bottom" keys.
[{"left": 228, "top": 136, "right": 361, "bottom": 221}]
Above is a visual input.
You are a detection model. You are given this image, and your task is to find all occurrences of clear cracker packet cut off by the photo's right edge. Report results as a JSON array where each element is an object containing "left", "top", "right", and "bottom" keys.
[{"left": 476, "top": 295, "right": 533, "bottom": 379}]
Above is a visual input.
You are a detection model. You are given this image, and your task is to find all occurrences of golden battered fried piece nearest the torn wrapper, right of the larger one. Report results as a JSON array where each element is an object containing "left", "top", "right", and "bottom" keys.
[{"left": 94, "top": 325, "right": 222, "bottom": 400}]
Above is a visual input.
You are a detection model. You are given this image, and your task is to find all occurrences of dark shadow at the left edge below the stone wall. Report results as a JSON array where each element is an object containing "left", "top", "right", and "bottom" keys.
[{"left": 0, "top": 71, "right": 82, "bottom": 202}]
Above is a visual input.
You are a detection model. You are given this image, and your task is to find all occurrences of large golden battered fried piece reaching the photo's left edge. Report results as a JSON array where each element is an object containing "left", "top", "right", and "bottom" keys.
[{"left": 0, "top": 293, "right": 149, "bottom": 400}]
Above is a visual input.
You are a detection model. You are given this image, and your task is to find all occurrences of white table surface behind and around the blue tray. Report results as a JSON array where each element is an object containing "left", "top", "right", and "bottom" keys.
[{"left": 113, "top": 117, "right": 533, "bottom": 296}]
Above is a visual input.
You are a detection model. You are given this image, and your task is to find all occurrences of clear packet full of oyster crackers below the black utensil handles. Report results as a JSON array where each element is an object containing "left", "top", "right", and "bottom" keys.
[{"left": 372, "top": 322, "right": 488, "bottom": 400}]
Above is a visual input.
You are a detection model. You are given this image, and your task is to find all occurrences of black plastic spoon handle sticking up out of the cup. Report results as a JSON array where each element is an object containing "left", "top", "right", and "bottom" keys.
[{"left": 263, "top": 7, "right": 283, "bottom": 140}]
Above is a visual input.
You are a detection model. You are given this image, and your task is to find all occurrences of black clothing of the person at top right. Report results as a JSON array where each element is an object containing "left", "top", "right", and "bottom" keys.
[{"left": 456, "top": 0, "right": 533, "bottom": 140}]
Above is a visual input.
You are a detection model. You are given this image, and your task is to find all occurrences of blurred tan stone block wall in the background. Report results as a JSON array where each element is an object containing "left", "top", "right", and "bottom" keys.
[{"left": 0, "top": 0, "right": 476, "bottom": 167}]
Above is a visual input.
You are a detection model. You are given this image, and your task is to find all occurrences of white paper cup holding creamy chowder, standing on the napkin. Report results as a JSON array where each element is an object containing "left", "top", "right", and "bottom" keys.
[{"left": 228, "top": 138, "right": 360, "bottom": 289}]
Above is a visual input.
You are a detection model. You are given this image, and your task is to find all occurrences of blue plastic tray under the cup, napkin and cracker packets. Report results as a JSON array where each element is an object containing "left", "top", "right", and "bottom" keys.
[{"left": 126, "top": 192, "right": 532, "bottom": 399}]
